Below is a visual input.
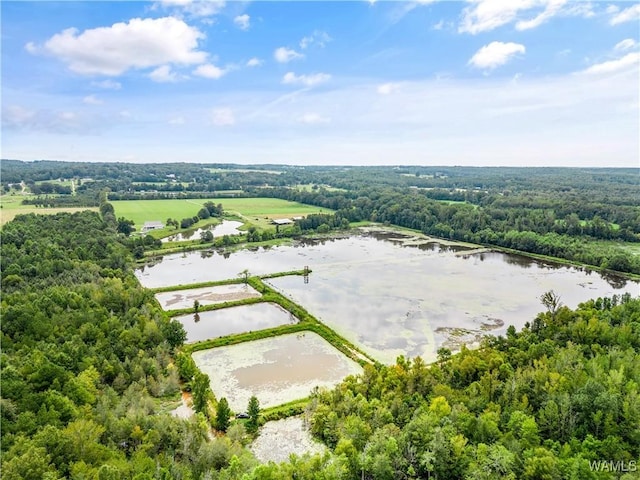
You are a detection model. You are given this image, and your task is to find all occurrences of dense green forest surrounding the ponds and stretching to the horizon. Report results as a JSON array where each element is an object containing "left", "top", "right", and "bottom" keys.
[{"left": 0, "top": 160, "right": 640, "bottom": 480}]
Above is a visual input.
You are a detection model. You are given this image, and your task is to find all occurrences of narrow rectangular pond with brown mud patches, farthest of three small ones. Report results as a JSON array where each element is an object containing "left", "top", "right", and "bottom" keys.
[{"left": 155, "top": 283, "right": 260, "bottom": 310}]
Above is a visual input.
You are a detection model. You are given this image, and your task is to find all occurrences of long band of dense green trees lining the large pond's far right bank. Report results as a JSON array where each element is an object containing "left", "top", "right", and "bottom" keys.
[{"left": 254, "top": 187, "right": 640, "bottom": 274}]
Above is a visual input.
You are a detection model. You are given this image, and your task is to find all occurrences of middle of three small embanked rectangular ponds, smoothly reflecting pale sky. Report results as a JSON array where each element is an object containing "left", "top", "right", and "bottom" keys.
[{"left": 174, "top": 303, "right": 298, "bottom": 343}]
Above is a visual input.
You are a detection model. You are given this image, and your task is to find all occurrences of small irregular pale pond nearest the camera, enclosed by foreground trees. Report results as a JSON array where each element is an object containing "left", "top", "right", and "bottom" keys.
[{"left": 249, "top": 417, "right": 327, "bottom": 463}]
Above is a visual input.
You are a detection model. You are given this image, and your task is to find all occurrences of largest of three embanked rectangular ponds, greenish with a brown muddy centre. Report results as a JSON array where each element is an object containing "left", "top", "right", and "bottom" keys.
[{"left": 193, "top": 332, "right": 362, "bottom": 413}]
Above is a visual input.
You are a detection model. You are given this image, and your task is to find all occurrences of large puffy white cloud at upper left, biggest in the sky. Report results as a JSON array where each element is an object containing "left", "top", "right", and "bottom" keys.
[{"left": 36, "top": 17, "right": 207, "bottom": 76}]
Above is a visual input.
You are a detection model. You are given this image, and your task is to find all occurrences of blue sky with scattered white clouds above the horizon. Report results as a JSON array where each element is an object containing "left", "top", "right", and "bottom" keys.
[{"left": 0, "top": 0, "right": 640, "bottom": 167}]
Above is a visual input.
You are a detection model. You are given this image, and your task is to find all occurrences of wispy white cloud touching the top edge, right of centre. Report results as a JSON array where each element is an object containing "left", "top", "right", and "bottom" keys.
[{"left": 458, "top": 0, "right": 594, "bottom": 35}]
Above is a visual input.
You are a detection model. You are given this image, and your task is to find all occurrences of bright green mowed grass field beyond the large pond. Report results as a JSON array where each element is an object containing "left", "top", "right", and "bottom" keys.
[{"left": 111, "top": 198, "right": 332, "bottom": 227}]
